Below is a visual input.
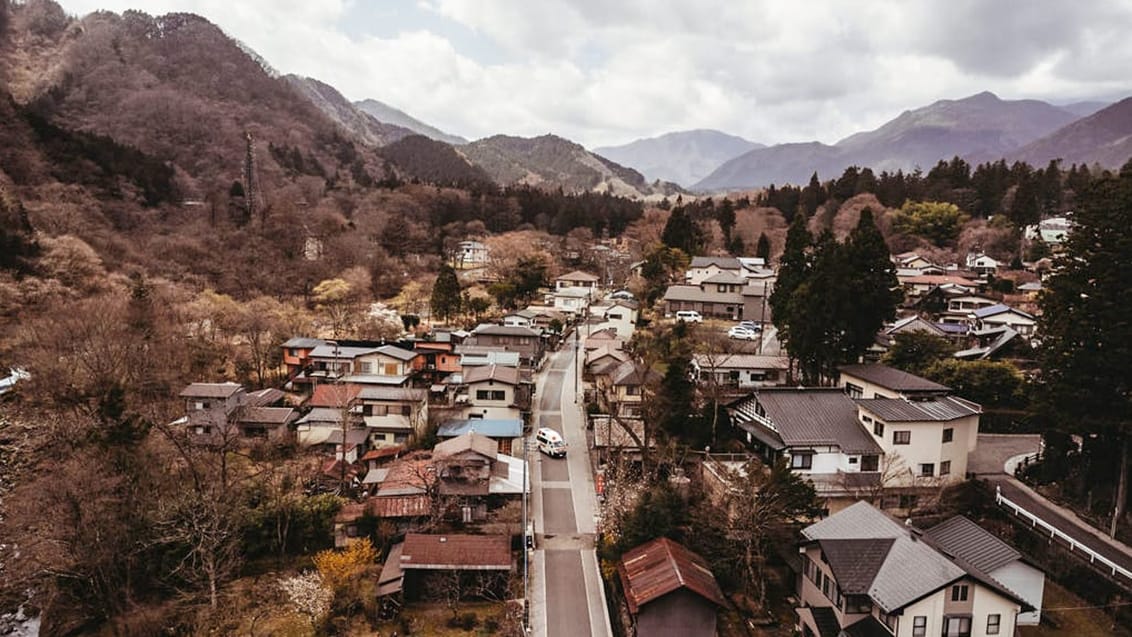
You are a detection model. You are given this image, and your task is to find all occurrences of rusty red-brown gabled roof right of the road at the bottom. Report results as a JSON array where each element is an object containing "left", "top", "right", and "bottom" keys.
[{"left": 617, "top": 537, "right": 727, "bottom": 614}]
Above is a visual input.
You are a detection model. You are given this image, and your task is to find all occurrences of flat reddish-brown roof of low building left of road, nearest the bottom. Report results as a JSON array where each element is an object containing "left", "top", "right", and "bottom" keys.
[{"left": 401, "top": 533, "right": 511, "bottom": 570}]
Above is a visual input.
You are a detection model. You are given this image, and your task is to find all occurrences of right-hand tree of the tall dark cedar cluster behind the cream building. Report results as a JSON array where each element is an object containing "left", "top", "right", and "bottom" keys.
[{"left": 844, "top": 207, "right": 903, "bottom": 362}]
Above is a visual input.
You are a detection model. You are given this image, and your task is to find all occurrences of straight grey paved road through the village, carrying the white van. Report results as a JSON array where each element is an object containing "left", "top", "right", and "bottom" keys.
[{"left": 531, "top": 346, "right": 610, "bottom": 637}]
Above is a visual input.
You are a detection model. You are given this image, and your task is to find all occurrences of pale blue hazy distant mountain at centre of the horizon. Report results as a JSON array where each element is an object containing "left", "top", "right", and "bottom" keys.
[{"left": 593, "top": 129, "right": 764, "bottom": 186}]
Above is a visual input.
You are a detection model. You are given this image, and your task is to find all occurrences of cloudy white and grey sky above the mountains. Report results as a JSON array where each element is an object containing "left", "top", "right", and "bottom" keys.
[{"left": 61, "top": 0, "right": 1132, "bottom": 147}]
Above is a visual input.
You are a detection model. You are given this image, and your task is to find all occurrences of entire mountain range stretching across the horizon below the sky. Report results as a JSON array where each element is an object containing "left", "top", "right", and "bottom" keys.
[{"left": 0, "top": 0, "right": 1132, "bottom": 198}]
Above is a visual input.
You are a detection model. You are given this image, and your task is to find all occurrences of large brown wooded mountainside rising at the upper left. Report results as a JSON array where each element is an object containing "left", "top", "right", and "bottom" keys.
[{"left": 0, "top": 6, "right": 383, "bottom": 198}]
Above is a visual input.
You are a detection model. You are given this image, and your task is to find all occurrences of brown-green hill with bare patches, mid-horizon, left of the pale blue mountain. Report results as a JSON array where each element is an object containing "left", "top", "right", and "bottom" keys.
[{"left": 460, "top": 135, "right": 659, "bottom": 197}]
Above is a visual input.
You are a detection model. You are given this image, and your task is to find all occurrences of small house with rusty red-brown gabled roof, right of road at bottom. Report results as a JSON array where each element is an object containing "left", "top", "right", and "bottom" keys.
[{"left": 617, "top": 537, "right": 728, "bottom": 637}]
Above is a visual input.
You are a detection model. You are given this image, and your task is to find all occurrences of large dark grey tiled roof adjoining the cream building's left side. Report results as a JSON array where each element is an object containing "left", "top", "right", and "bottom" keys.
[{"left": 742, "top": 388, "right": 883, "bottom": 454}]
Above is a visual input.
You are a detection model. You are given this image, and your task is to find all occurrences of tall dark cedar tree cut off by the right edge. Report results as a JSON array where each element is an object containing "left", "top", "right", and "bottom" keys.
[{"left": 1039, "top": 161, "right": 1132, "bottom": 535}]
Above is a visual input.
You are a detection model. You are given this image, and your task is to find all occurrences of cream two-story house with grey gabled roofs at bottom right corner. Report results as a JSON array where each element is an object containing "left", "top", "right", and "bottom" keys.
[{"left": 795, "top": 502, "right": 1034, "bottom": 637}]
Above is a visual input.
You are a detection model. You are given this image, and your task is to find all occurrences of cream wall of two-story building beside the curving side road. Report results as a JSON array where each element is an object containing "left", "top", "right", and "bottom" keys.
[{"left": 860, "top": 408, "right": 979, "bottom": 485}]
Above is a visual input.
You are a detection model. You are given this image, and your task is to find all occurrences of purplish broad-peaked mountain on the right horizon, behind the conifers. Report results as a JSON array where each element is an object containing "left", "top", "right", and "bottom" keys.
[{"left": 693, "top": 93, "right": 1077, "bottom": 190}]
